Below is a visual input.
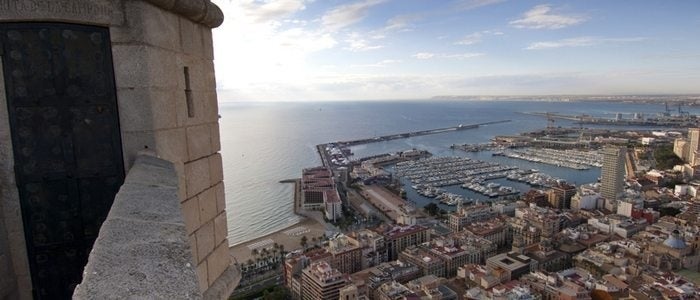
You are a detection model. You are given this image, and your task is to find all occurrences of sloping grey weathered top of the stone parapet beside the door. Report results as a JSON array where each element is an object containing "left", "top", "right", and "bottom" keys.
[{"left": 74, "top": 156, "right": 201, "bottom": 299}]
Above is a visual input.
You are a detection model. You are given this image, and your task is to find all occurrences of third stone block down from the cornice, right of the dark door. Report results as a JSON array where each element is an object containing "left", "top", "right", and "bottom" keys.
[{"left": 117, "top": 88, "right": 177, "bottom": 131}]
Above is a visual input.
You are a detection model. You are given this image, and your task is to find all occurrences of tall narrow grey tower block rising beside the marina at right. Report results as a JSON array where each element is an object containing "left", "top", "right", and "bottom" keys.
[{"left": 600, "top": 146, "right": 627, "bottom": 201}]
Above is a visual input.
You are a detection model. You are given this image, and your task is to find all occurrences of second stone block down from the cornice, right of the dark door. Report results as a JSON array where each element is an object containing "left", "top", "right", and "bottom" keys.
[{"left": 112, "top": 44, "right": 183, "bottom": 90}]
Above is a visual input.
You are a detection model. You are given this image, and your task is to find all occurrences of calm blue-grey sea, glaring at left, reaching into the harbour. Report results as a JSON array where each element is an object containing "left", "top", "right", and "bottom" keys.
[{"left": 219, "top": 100, "right": 700, "bottom": 245}]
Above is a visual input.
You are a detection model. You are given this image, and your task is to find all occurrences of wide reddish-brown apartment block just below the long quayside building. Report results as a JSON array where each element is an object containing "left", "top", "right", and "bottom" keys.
[{"left": 373, "top": 225, "right": 430, "bottom": 261}]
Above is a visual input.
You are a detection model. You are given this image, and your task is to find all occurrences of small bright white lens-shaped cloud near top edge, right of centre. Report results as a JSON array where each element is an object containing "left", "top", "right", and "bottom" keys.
[{"left": 510, "top": 4, "right": 587, "bottom": 29}]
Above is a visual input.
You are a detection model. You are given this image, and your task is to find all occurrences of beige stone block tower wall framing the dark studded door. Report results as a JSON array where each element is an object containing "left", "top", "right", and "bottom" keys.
[{"left": 0, "top": 0, "right": 235, "bottom": 298}]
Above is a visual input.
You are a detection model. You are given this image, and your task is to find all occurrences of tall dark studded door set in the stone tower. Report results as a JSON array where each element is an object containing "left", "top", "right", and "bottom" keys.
[{"left": 0, "top": 23, "right": 124, "bottom": 299}]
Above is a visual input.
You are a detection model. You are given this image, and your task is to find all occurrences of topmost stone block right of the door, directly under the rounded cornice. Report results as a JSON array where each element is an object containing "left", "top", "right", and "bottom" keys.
[{"left": 110, "top": 1, "right": 180, "bottom": 51}]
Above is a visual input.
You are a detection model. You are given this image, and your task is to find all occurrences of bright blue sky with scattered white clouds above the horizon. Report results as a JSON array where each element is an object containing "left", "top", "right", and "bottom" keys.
[{"left": 212, "top": 0, "right": 700, "bottom": 102}]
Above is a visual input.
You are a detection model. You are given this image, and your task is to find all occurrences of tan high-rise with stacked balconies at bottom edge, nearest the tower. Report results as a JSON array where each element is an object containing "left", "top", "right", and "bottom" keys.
[{"left": 301, "top": 261, "right": 347, "bottom": 300}]
